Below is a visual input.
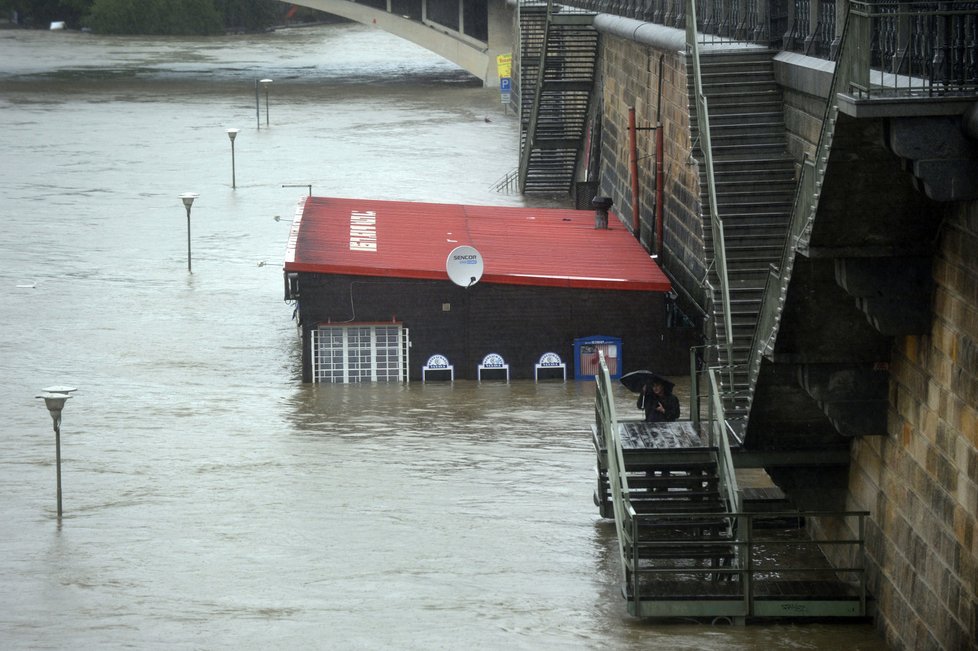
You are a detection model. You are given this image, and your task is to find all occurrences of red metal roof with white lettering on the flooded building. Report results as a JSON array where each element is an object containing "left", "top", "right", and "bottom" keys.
[{"left": 285, "top": 197, "right": 671, "bottom": 292}]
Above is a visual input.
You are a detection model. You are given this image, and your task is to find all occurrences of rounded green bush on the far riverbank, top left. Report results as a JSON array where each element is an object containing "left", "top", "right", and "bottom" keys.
[{"left": 86, "top": 0, "right": 224, "bottom": 35}]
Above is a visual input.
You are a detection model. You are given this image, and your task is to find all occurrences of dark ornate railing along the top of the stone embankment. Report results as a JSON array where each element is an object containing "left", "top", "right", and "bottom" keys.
[{"left": 562, "top": 0, "right": 978, "bottom": 88}]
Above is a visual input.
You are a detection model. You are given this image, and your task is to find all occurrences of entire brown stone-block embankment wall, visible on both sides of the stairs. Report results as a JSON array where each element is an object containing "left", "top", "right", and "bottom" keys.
[{"left": 600, "top": 35, "right": 978, "bottom": 651}]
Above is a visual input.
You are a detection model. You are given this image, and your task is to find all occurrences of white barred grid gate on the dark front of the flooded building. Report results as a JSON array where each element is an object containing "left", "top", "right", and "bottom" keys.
[{"left": 312, "top": 323, "right": 410, "bottom": 383}]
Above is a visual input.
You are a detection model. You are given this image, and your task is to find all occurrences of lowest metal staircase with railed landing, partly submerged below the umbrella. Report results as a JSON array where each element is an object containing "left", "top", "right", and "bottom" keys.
[{"left": 593, "top": 355, "right": 870, "bottom": 623}]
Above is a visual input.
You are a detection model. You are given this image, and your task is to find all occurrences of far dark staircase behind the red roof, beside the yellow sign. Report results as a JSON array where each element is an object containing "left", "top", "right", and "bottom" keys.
[{"left": 519, "top": 1, "right": 598, "bottom": 194}]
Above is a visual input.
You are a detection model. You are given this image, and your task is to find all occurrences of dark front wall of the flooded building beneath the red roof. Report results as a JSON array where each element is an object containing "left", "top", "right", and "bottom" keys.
[{"left": 299, "top": 274, "right": 693, "bottom": 381}]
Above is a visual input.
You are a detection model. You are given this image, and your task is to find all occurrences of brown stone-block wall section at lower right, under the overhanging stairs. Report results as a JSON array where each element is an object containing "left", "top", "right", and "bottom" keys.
[{"left": 849, "top": 203, "right": 978, "bottom": 650}]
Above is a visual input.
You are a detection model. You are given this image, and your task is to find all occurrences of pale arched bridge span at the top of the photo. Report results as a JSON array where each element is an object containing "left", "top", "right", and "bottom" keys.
[{"left": 290, "top": 0, "right": 512, "bottom": 86}]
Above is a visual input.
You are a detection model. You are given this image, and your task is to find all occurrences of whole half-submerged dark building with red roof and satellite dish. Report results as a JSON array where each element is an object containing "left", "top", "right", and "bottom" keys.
[{"left": 285, "top": 197, "right": 691, "bottom": 382}]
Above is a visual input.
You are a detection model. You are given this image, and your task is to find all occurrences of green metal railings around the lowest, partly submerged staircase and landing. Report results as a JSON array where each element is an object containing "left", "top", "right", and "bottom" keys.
[{"left": 595, "top": 354, "right": 869, "bottom": 618}]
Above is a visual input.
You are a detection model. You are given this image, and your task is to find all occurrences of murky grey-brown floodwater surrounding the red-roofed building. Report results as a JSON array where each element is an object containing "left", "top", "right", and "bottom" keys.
[{"left": 0, "top": 25, "right": 883, "bottom": 650}]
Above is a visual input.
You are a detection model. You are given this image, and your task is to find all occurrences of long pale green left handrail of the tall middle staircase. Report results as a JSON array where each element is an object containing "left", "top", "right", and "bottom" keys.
[{"left": 686, "top": 0, "right": 734, "bottom": 392}]
